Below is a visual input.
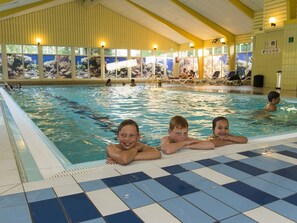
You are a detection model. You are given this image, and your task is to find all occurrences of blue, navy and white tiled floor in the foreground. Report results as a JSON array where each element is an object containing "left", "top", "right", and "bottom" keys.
[{"left": 0, "top": 140, "right": 297, "bottom": 223}]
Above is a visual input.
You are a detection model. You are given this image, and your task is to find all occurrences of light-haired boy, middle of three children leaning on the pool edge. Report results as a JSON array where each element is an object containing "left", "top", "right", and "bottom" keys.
[{"left": 160, "top": 116, "right": 214, "bottom": 154}]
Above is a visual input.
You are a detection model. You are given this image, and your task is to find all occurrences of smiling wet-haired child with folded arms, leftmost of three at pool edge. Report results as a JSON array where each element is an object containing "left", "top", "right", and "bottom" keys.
[{"left": 106, "top": 119, "right": 161, "bottom": 165}]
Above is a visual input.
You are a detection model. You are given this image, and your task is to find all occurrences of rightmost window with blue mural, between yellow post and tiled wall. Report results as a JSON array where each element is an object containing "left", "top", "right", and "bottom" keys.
[{"left": 236, "top": 43, "right": 253, "bottom": 77}]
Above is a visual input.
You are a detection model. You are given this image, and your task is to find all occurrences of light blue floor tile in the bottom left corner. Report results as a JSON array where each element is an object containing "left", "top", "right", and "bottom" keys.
[{"left": 0, "top": 204, "right": 32, "bottom": 223}]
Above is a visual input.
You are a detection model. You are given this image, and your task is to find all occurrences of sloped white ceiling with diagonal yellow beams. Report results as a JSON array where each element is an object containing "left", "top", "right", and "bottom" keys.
[{"left": 0, "top": 0, "right": 264, "bottom": 44}]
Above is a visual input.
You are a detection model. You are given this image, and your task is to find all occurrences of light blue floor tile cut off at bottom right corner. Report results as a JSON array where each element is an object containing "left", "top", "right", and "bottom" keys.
[{"left": 265, "top": 197, "right": 297, "bottom": 222}]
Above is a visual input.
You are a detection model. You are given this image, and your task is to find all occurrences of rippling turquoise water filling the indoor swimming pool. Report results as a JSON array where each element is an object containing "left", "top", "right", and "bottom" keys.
[{"left": 12, "top": 86, "right": 297, "bottom": 163}]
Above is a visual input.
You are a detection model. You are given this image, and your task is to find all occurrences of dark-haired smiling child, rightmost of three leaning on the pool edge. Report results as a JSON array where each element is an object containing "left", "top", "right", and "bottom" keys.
[{"left": 208, "top": 116, "right": 248, "bottom": 147}]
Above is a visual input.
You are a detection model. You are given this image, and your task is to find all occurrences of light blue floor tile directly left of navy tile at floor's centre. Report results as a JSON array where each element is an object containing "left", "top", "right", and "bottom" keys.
[{"left": 134, "top": 179, "right": 178, "bottom": 202}]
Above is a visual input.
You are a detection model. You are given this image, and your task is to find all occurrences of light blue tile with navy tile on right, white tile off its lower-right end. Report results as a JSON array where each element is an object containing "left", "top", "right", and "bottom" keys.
[{"left": 204, "top": 187, "right": 259, "bottom": 212}]
